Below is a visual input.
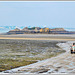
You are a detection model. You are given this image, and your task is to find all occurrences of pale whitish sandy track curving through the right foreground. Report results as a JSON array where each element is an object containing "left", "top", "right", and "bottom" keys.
[{"left": 1, "top": 41, "right": 75, "bottom": 74}]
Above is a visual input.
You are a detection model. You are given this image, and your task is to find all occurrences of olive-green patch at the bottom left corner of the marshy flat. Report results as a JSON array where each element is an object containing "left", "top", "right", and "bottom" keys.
[{"left": 0, "top": 59, "right": 36, "bottom": 72}]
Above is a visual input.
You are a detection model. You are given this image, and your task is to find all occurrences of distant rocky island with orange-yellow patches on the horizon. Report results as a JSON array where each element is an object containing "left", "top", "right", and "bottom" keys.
[{"left": 7, "top": 27, "right": 75, "bottom": 34}]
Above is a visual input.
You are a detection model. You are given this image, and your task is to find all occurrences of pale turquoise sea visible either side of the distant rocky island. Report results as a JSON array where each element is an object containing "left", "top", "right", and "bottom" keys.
[{"left": 0, "top": 26, "right": 75, "bottom": 34}]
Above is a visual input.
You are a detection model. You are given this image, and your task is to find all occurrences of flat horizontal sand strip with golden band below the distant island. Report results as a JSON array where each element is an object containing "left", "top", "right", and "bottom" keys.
[{"left": 0, "top": 34, "right": 75, "bottom": 41}]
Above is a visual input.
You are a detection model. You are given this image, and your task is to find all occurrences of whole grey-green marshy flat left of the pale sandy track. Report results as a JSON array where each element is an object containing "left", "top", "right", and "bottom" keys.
[{"left": 0, "top": 39, "right": 65, "bottom": 72}]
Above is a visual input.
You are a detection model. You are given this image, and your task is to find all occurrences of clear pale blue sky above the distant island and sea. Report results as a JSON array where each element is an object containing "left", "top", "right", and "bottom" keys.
[{"left": 0, "top": 1, "right": 75, "bottom": 28}]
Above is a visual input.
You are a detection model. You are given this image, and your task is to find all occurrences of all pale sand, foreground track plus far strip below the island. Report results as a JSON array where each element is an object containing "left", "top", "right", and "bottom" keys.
[{"left": 0, "top": 34, "right": 75, "bottom": 74}]
